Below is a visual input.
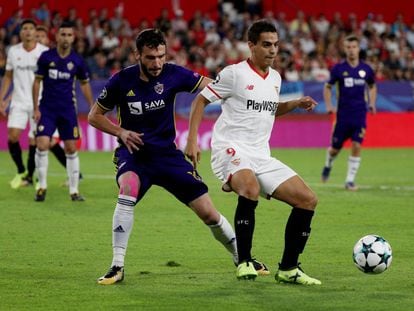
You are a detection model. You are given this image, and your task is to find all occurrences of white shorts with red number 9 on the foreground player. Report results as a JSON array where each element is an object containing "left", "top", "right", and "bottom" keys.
[{"left": 211, "top": 144, "right": 297, "bottom": 198}]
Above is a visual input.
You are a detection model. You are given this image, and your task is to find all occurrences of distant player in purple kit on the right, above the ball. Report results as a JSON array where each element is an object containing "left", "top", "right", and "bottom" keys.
[{"left": 322, "top": 35, "right": 377, "bottom": 191}]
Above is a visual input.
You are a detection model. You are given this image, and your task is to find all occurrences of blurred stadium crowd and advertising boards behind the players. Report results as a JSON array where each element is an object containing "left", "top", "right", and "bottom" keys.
[{"left": 0, "top": 0, "right": 414, "bottom": 151}]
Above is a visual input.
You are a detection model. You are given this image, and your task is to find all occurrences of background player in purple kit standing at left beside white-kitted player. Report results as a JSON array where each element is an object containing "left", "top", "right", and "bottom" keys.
[{"left": 33, "top": 23, "right": 93, "bottom": 202}]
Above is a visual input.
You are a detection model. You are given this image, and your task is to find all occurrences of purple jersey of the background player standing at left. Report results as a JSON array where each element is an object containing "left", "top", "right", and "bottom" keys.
[{"left": 35, "top": 49, "right": 89, "bottom": 112}]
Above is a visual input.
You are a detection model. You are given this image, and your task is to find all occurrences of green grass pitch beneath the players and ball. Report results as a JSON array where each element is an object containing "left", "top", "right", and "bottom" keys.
[{"left": 0, "top": 149, "right": 414, "bottom": 311}]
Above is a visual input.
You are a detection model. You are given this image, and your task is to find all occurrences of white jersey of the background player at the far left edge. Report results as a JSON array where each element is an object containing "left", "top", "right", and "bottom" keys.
[{"left": 6, "top": 43, "right": 49, "bottom": 108}]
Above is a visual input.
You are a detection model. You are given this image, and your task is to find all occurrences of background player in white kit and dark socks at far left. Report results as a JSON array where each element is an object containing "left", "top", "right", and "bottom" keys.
[{"left": 0, "top": 19, "right": 48, "bottom": 189}]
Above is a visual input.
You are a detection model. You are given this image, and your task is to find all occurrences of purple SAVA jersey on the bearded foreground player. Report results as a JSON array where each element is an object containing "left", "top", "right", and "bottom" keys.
[{"left": 97, "top": 64, "right": 203, "bottom": 152}]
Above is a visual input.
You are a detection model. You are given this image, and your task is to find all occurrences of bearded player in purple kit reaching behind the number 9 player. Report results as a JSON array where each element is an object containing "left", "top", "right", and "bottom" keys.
[{"left": 89, "top": 29, "right": 267, "bottom": 285}]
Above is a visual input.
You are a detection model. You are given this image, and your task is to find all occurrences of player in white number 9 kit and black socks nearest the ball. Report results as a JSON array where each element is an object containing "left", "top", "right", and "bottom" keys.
[{"left": 185, "top": 20, "right": 321, "bottom": 285}]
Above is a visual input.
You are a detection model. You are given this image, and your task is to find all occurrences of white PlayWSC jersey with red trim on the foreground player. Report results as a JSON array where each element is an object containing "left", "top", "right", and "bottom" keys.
[{"left": 201, "top": 60, "right": 282, "bottom": 152}]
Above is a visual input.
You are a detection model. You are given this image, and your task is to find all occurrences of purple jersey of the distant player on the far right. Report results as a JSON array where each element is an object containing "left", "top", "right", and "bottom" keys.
[{"left": 328, "top": 61, "right": 375, "bottom": 121}]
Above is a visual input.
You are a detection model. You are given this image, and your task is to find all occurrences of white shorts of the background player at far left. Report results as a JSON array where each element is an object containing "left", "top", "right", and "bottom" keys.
[{"left": 7, "top": 102, "right": 36, "bottom": 138}]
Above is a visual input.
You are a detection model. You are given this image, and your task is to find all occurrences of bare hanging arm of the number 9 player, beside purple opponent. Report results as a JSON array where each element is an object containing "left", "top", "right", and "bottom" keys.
[{"left": 184, "top": 94, "right": 210, "bottom": 169}]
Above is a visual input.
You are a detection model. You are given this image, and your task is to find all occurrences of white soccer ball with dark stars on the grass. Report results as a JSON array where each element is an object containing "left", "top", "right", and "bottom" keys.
[{"left": 353, "top": 234, "right": 392, "bottom": 274}]
